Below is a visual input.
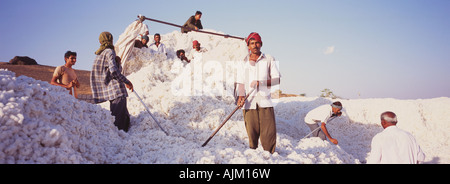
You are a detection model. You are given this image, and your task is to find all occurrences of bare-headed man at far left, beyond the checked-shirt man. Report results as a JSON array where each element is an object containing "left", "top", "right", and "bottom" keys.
[{"left": 50, "top": 51, "right": 80, "bottom": 98}]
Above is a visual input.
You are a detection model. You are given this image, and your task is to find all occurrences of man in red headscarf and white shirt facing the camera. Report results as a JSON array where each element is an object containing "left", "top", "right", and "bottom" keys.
[{"left": 236, "top": 32, "right": 281, "bottom": 153}]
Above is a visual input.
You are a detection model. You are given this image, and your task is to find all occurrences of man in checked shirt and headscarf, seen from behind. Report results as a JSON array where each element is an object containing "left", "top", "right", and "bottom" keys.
[{"left": 90, "top": 32, "right": 133, "bottom": 132}]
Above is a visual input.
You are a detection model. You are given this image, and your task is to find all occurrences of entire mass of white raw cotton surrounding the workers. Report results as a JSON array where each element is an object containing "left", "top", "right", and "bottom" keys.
[{"left": 0, "top": 29, "right": 450, "bottom": 164}]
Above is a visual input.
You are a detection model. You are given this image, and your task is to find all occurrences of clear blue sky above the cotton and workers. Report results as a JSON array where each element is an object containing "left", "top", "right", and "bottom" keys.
[{"left": 0, "top": 0, "right": 450, "bottom": 99}]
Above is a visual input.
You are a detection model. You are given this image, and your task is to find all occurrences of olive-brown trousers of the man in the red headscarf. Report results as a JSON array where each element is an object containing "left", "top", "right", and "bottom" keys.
[{"left": 244, "top": 106, "right": 277, "bottom": 153}]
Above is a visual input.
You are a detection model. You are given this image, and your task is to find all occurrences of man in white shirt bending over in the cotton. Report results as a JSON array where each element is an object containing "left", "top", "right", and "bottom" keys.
[{"left": 305, "top": 101, "right": 342, "bottom": 144}]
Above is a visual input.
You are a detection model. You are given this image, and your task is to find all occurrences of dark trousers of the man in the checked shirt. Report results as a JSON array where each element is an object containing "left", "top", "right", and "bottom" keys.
[{"left": 109, "top": 96, "right": 130, "bottom": 132}]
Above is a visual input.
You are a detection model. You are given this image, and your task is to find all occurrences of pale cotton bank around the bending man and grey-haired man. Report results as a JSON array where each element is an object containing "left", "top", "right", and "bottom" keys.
[{"left": 275, "top": 97, "right": 450, "bottom": 163}]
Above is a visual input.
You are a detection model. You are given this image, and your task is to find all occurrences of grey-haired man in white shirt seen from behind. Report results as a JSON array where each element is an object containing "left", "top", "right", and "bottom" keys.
[{"left": 367, "top": 111, "right": 425, "bottom": 164}]
